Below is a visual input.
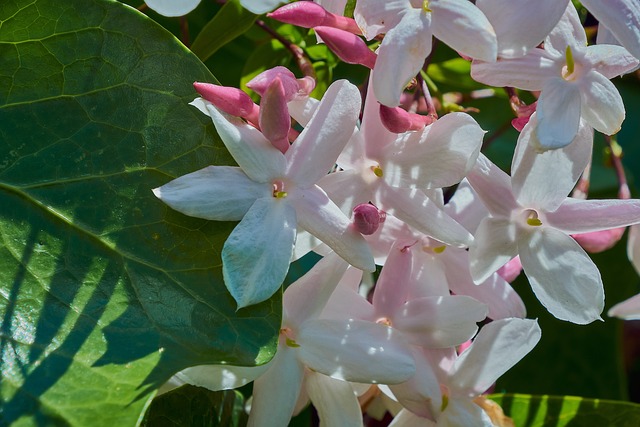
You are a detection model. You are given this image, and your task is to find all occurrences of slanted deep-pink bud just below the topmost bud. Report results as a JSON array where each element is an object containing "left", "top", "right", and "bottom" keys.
[{"left": 315, "top": 27, "right": 378, "bottom": 69}]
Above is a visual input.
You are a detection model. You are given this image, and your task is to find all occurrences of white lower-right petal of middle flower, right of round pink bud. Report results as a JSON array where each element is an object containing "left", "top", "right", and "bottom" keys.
[{"left": 378, "top": 185, "right": 473, "bottom": 247}]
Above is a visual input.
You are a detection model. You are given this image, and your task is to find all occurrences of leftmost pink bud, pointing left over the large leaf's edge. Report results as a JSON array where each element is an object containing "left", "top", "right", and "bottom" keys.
[{"left": 193, "top": 82, "right": 260, "bottom": 125}]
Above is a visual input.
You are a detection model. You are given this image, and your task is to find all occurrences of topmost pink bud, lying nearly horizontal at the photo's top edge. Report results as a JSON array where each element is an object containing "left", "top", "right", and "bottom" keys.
[{"left": 267, "top": 1, "right": 361, "bottom": 34}]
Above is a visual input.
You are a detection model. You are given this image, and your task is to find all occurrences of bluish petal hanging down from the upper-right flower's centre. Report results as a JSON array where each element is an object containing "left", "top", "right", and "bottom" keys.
[{"left": 536, "top": 77, "right": 581, "bottom": 150}]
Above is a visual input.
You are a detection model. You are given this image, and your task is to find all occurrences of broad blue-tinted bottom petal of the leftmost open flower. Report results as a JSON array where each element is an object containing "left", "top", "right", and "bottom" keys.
[{"left": 222, "top": 197, "right": 296, "bottom": 308}]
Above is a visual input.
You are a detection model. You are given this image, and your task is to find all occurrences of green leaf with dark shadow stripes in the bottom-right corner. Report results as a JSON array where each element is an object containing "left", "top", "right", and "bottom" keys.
[{"left": 489, "top": 394, "right": 640, "bottom": 427}]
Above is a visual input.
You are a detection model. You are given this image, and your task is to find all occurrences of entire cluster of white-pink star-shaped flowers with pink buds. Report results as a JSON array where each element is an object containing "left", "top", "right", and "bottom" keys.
[{"left": 150, "top": 0, "right": 640, "bottom": 426}]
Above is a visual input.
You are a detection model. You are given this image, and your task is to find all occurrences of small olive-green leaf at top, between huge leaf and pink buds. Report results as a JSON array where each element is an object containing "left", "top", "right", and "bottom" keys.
[{"left": 191, "top": 0, "right": 258, "bottom": 61}]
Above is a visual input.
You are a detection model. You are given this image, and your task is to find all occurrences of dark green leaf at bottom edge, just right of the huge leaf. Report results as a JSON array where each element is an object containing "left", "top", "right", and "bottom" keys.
[{"left": 142, "top": 385, "right": 248, "bottom": 427}]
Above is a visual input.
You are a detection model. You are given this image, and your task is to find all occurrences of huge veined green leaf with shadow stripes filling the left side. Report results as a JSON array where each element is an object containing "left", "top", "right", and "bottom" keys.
[{"left": 0, "top": 0, "right": 281, "bottom": 426}]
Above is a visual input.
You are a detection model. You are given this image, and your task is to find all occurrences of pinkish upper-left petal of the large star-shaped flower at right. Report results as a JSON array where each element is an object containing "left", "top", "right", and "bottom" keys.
[{"left": 467, "top": 153, "right": 519, "bottom": 218}]
